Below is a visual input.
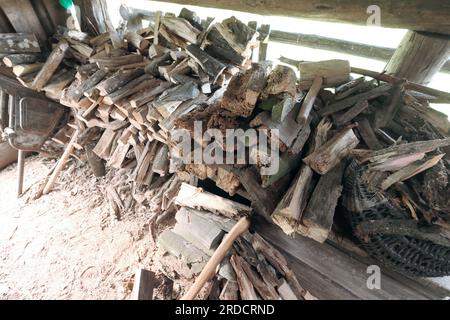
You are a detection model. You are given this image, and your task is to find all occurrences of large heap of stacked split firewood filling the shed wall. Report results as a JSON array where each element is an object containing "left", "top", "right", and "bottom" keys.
[{"left": 2, "top": 5, "right": 450, "bottom": 284}]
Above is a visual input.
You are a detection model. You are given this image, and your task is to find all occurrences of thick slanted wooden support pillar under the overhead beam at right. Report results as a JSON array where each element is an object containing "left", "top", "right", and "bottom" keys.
[{"left": 385, "top": 31, "right": 450, "bottom": 84}]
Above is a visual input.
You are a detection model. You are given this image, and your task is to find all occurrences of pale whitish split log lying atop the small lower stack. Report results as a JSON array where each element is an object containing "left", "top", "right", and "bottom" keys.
[{"left": 175, "top": 183, "right": 251, "bottom": 218}]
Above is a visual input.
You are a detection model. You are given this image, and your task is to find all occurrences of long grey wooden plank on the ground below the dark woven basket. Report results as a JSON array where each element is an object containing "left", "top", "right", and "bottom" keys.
[{"left": 253, "top": 218, "right": 449, "bottom": 300}]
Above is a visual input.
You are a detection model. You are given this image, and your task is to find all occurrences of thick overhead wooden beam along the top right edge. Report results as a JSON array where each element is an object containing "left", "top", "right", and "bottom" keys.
[{"left": 159, "top": 0, "right": 450, "bottom": 34}]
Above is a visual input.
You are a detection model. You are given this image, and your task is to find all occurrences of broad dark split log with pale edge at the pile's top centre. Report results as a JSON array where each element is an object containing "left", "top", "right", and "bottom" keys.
[{"left": 202, "top": 17, "right": 257, "bottom": 65}]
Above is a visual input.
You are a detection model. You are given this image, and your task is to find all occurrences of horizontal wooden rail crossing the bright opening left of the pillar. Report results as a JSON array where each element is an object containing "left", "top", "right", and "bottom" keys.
[{"left": 269, "top": 30, "right": 450, "bottom": 73}]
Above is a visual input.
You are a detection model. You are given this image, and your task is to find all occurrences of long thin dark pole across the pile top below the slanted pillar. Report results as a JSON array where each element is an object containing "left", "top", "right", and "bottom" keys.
[{"left": 351, "top": 67, "right": 450, "bottom": 103}]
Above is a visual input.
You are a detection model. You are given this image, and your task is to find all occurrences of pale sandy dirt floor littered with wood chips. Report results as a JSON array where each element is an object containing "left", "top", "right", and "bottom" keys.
[{"left": 0, "top": 156, "right": 192, "bottom": 299}]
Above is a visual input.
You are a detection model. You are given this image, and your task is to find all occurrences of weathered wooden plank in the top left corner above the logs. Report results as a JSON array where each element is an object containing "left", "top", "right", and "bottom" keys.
[{"left": 0, "top": 0, "right": 47, "bottom": 43}]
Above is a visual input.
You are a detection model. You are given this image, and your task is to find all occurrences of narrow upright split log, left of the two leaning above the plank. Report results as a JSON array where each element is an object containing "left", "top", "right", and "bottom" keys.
[{"left": 272, "top": 165, "right": 314, "bottom": 228}]
